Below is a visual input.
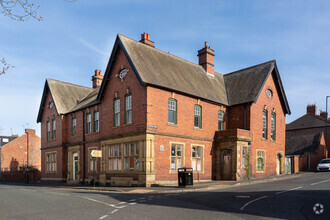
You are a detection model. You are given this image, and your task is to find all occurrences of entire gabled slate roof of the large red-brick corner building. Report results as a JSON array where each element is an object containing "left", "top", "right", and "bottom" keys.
[{"left": 37, "top": 34, "right": 290, "bottom": 122}]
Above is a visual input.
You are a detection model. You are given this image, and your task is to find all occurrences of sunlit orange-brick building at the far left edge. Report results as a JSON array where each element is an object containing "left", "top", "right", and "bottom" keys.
[{"left": 1, "top": 129, "right": 41, "bottom": 171}]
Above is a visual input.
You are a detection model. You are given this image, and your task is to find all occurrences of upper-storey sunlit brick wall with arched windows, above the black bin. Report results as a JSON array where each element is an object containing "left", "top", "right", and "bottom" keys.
[{"left": 147, "top": 86, "right": 227, "bottom": 139}]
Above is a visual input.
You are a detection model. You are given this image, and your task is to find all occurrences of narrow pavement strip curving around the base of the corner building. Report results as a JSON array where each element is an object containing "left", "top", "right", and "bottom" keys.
[{"left": 64, "top": 172, "right": 309, "bottom": 193}]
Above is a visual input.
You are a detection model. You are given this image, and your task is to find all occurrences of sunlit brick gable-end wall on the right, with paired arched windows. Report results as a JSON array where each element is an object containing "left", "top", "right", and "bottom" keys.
[{"left": 250, "top": 74, "right": 285, "bottom": 176}]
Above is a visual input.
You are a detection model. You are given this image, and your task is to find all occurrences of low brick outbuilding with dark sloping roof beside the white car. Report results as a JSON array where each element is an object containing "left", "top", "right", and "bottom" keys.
[{"left": 285, "top": 132, "right": 328, "bottom": 173}]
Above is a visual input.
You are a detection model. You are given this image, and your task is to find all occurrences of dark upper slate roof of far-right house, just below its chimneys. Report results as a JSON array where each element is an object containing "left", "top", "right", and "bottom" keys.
[{"left": 286, "top": 114, "right": 330, "bottom": 130}]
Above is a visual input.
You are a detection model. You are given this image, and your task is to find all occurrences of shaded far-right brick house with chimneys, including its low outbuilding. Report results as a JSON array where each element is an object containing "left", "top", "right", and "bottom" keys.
[{"left": 285, "top": 105, "right": 330, "bottom": 173}]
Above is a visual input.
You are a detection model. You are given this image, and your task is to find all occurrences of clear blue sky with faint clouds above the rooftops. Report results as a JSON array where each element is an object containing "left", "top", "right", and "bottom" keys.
[{"left": 0, "top": 0, "right": 330, "bottom": 135}]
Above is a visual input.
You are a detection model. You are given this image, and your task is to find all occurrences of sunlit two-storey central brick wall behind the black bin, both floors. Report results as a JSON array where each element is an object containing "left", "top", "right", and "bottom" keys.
[{"left": 147, "top": 86, "right": 227, "bottom": 181}]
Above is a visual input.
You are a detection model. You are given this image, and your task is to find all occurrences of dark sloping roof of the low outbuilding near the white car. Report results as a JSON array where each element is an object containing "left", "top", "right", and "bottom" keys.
[{"left": 285, "top": 132, "right": 323, "bottom": 155}]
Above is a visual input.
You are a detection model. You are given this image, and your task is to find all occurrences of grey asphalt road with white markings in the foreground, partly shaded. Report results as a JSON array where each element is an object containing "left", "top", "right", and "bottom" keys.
[{"left": 0, "top": 172, "right": 330, "bottom": 219}]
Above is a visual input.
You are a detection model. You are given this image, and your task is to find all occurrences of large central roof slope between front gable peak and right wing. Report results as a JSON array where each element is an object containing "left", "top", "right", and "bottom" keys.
[{"left": 114, "top": 34, "right": 228, "bottom": 105}]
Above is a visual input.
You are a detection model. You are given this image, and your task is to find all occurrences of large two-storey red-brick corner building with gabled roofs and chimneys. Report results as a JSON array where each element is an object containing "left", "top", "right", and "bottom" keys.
[{"left": 37, "top": 33, "right": 290, "bottom": 186}]
